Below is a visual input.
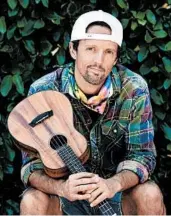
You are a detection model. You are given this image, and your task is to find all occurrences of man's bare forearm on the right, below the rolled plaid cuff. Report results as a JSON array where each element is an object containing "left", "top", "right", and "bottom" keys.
[{"left": 108, "top": 170, "right": 139, "bottom": 192}]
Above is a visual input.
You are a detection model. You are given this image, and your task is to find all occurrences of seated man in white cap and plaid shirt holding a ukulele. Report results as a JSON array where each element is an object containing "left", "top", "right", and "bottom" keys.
[{"left": 21, "top": 11, "right": 165, "bottom": 215}]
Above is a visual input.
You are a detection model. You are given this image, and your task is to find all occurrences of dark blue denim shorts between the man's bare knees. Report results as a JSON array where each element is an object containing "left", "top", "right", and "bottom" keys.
[{"left": 60, "top": 192, "right": 122, "bottom": 215}]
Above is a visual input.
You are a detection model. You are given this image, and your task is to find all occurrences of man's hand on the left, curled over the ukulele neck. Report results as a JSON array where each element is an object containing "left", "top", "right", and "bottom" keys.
[{"left": 60, "top": 172, "right": 99, "bottom": 201}]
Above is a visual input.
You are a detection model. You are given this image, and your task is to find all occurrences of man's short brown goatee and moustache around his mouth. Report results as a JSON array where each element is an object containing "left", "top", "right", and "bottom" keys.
[{"left": 82, "top": 65, "right": 106, "bottom": 85}]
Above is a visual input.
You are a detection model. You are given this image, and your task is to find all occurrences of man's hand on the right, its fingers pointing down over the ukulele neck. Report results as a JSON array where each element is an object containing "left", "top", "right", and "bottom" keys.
[{"left": 86, "top": 175, "right": 121, "bottom": 207}]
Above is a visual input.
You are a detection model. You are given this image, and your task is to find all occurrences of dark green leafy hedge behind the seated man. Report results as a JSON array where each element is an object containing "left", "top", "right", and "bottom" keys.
[{"left": 0, "top": 0, "right": 171, "bottom": 214}]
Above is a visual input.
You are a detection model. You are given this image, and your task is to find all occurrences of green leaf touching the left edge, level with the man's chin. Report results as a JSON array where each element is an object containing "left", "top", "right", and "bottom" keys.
[{"left": 0, "top": 75, "right": 12, "bottom": 97}]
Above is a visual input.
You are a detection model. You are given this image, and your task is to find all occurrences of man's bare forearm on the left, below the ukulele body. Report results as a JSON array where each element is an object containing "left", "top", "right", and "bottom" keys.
[{"left": 29, "top": 170, "right": 64, "bottom": 196}]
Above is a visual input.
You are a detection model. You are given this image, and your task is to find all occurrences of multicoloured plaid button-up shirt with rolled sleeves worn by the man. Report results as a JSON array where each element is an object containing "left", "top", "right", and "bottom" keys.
[{"left": 21, "top": 64, "right": 156, "bottom": 185}]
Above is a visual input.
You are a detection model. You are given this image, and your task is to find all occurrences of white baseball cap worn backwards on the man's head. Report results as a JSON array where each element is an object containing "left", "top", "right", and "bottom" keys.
[{"left": 71, "top": 10, "right": 123, "bottom": 46}]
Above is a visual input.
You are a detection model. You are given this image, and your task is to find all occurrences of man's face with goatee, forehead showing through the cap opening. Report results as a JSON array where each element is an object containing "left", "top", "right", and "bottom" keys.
[{"left": 70, "top": 25, "right": 118, "bottom": 85}]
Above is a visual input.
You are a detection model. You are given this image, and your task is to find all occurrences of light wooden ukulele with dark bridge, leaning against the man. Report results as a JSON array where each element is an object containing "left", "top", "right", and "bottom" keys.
[{"left": 8, "top": 90, "right": 116, "bottom": 215}]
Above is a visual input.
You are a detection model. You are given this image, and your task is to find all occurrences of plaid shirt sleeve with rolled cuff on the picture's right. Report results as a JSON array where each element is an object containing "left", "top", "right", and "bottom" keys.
[{"left": 117, "top": 89, "right": 156, "bottom": 183}]
